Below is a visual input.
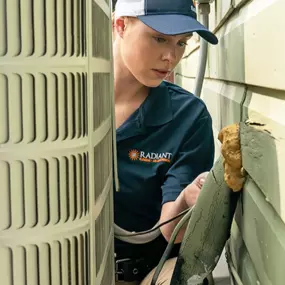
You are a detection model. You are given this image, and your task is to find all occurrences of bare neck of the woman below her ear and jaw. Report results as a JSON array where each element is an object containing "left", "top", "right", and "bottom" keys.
[{"left": 114, "top": 42, "right": 148, "bottom": 103}]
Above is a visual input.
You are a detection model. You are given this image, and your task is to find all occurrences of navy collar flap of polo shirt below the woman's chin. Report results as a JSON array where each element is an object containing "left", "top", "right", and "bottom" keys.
[{"left": 140, "top": 82, "right": 173, "bottom": 126}]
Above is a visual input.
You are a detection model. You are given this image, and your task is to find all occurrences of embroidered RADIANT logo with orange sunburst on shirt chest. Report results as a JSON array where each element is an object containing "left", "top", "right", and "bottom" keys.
[{"left": 129, "top": 149, "right": 172, "bottom": 163}]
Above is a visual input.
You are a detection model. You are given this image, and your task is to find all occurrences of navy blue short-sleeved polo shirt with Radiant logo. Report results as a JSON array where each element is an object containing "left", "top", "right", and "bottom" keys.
[{"left": 114, "top": 81, "right": 214, "bottom": 256}]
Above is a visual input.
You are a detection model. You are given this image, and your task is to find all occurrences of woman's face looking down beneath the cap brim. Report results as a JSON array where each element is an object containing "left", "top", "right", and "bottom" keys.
[{"left": 113, "top": 18, "right": 191, "bottom": 87}]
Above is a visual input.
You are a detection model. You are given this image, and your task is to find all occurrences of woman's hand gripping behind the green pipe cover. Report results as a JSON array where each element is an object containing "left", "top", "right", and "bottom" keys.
[{"left": 183, "top": 172, "right": 209, "bottom": 208}]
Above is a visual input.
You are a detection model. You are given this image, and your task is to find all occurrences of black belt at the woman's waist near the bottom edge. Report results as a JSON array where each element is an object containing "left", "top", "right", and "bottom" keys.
[{"left": 115, "top": 258, "right": 154, "bottom": 282}]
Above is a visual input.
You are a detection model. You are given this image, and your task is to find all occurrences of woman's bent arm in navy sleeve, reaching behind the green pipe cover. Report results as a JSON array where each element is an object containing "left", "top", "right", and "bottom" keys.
[{"left": 160, "top": 113, "right": 214, "bottom": 242}]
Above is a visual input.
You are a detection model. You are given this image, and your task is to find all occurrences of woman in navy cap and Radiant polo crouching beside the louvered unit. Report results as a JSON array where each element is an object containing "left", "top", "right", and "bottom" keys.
[{"left": 113, "top": 0, "right": 217, "bottom": 285}]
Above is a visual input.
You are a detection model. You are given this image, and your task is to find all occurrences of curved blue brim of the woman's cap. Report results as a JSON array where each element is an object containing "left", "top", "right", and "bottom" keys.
[{"left": 138, "top": 14, "right": 218, "bottom": 45}]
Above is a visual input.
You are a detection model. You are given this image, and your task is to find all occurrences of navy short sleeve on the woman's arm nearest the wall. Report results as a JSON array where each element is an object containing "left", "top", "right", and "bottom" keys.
[{"left": 162, "top": 115, "right": 215, "bottom": 204}]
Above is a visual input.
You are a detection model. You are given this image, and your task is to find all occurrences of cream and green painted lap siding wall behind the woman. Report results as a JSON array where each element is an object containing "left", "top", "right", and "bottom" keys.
[{"left": 175, "top": 0, "right": 285, "bottom": 285}]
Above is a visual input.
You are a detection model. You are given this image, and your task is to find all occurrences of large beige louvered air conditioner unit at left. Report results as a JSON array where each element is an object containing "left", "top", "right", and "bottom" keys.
[{"left": 0, "top": 0, "right": 114, "bottom": 285}]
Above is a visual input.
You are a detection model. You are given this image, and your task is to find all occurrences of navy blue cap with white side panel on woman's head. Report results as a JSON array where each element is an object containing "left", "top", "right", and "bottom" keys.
[{"left": 116, "top": 0, "right": 218, "bottom": 44}]
